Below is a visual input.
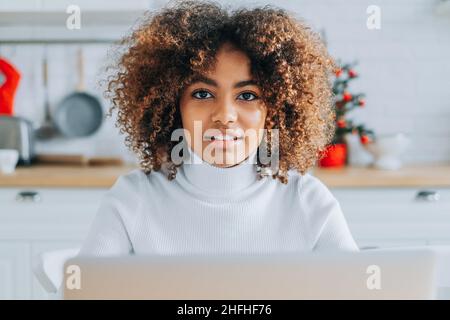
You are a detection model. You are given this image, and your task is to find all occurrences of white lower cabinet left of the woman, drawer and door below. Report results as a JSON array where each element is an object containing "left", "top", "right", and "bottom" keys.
[{"left": 0, "top": 187, "right": 107, "bottom": 299}]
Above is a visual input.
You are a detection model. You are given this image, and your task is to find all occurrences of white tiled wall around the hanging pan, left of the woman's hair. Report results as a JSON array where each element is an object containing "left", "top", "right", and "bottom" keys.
[{"left": 0, "top": 44, "right": 138, "bottom": 161}]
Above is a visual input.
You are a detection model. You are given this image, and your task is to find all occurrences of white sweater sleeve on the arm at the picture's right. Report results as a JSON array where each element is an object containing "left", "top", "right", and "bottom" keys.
[{"left": 300, "top": 173, "right": 359, "bottom": 251}]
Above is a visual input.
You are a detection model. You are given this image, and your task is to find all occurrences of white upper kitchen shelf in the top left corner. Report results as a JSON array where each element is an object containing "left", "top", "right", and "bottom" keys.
[{"left": 0, "top": 1, "right": 162, "bottom": 45}]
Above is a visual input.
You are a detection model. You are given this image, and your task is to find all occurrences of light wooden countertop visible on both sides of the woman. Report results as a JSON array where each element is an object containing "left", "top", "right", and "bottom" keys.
[{"left": 0, "top": 164, "right": 450, "bottom": 188}]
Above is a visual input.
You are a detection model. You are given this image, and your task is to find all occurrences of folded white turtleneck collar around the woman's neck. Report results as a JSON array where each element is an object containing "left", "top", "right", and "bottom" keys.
[{"left": 180, "top": 146, "right": 258, "bottom": 196}]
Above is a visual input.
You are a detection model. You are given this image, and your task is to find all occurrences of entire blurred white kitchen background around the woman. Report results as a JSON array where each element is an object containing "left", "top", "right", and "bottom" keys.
[{"left": 0, "top": 0, "right": 450, "bottom": 298}]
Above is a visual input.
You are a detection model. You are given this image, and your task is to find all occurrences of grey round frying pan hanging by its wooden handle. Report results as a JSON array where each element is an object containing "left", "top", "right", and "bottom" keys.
[{"left": 53, "top": 48, "right": 103, "bottom": 138}]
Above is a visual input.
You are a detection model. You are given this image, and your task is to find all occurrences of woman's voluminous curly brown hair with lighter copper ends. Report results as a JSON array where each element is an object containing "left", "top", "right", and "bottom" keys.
[{"left": 105, "top": 1, "right": 336, "bottom": 183}]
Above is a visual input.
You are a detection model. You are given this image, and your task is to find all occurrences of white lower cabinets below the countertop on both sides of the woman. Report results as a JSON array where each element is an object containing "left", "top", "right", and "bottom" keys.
[{"left": 0, "top": 187, "right": 450, "bottom": 299}]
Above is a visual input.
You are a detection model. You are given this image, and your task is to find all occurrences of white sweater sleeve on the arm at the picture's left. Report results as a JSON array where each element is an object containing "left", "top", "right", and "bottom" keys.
[{"left": 75, "top": 170, "right": 143, "bottom": 256}]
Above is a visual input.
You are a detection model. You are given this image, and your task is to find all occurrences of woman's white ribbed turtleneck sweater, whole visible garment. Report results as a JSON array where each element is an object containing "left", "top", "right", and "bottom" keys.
[{"left": 80, "top": 148, "right": 358, "bottom": 256}]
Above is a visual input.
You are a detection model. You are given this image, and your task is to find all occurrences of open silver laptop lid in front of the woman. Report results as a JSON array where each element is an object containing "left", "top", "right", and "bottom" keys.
[{"left": 63, "top": 249, "right": 437, "bottom": 300}]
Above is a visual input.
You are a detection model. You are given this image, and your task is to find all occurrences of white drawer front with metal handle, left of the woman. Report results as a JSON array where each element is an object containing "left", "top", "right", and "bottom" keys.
[{"left": 0, "top": 188, "right": 107, "bottom": 240}]
